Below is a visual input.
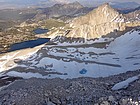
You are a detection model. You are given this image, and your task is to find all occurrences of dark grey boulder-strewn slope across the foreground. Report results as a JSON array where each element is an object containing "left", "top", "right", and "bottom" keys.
[{"left": 0, "top": 70, "right": 140, "bottom": 105}]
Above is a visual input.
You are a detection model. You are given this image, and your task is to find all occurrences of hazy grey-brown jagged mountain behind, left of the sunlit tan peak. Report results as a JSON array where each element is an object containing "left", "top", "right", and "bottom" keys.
[{"left": 36, "top": 1, "right": 93, "bottom": 20}]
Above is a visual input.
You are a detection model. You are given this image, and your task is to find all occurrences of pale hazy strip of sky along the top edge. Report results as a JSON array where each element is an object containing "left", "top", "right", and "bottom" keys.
[{"left": 0, "top": 0, "right": 140, "bottom": 7}]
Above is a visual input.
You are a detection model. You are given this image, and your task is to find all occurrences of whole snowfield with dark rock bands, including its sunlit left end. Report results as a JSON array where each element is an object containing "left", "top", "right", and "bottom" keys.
[{"left": 0, "top": 30, "right": 140, "bottom": 79}]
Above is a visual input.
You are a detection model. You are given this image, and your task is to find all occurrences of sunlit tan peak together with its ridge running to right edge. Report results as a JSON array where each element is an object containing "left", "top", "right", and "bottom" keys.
[{"left": 50, "top": 3, "right": 140, "bottom": 39}]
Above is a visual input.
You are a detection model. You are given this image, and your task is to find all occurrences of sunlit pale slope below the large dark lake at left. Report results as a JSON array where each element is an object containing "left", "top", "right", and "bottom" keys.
[{"left": 0, "top": 45, "right": 44, "bottom": 72}]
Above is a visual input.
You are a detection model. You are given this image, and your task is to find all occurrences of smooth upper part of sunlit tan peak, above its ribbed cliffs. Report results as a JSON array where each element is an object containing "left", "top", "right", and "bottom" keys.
[{"left": 73, "top": 3, "right": 121, "bottom": 26}]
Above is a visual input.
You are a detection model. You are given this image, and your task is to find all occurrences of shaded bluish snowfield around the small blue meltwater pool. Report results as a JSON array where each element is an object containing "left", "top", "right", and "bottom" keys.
[{"left": 24, "top": 31, "right": 140, "bottom": 78}]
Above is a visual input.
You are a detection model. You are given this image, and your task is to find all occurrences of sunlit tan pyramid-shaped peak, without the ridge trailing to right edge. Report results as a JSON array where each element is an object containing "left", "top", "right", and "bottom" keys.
[{"left": 67, "top": 4, "right": 125, "bottom": 39}]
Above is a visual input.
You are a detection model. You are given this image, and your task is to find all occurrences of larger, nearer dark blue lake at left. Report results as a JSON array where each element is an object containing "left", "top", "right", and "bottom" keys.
[{"left": 9, "top": 38, "right": 50, "bottom": 52}]
